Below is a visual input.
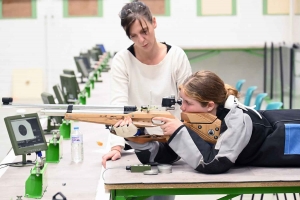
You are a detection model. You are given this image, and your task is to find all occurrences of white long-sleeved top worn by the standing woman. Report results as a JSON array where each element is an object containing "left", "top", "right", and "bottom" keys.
[{"left": 111, "top": 45, "right": 192, "bottom": 147}]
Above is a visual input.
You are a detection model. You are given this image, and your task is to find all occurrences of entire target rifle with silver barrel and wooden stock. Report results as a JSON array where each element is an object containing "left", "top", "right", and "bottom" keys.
[{"left": 2, "top": 97, "right": 221, "bottom": 144}]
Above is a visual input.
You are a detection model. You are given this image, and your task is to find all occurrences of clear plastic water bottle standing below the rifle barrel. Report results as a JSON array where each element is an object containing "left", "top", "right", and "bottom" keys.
[{"left": 71, "top": 126, "right": 83, "bottom": 163}]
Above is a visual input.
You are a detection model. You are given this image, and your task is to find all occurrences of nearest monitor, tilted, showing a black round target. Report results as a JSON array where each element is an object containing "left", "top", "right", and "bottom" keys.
[{"left": 4, "top": 113, "right": 48, "bottom": 155}]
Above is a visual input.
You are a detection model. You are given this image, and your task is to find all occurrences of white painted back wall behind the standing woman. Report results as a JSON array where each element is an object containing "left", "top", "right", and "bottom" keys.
[{"left": 0, "top": 0, "right": 300, "bottom": 97}]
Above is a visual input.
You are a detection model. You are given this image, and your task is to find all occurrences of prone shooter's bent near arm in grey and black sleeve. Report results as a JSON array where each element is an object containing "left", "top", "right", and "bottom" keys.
[{"left": 168, "top": 107, "right": 252, "bottom": 174}]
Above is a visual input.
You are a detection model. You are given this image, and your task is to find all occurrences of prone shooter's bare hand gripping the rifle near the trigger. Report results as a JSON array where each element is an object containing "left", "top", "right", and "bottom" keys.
[{"left": 153, "top": 117, "right": 183, "bottom": 135}]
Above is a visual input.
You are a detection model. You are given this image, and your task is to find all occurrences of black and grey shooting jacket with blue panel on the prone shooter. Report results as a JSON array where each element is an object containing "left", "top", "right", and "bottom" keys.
[{"left": 129, "top": 105, "right": 300, "bottom": 174}]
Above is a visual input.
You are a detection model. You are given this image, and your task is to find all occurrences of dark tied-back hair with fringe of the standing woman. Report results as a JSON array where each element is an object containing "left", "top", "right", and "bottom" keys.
[{"left": 119, "top": 0, "right": 152, "bottom": 38}]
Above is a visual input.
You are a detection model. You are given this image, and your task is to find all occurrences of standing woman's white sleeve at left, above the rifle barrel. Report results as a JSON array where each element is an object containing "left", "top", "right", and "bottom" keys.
[{"left": 110, "top": 54, "right": 129, "bottom": 105}]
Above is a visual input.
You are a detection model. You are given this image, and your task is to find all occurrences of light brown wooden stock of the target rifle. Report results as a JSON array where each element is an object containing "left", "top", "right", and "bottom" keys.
[{"left": 65, "top": 111, "right": 221, "bottom": 144}]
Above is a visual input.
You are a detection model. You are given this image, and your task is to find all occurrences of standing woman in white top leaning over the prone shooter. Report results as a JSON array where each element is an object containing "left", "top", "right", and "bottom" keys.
[{"left": 102, "top": 1, "right": 192, "bottom": 170}]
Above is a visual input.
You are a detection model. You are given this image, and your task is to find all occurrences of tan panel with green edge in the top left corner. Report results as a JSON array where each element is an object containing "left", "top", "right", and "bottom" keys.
[{"left": 0, "top": 0, "right": 36, "bottom": 19}]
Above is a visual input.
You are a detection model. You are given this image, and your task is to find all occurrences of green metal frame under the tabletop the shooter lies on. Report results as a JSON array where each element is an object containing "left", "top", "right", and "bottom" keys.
[{"left": 110, "top": 186, "right": 300, "bottom": 200}]
